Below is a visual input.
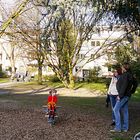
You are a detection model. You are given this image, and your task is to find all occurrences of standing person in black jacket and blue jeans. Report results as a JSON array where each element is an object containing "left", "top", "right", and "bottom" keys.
[{"left": 110, "top": 63, "right": 133, "bottom": 132}]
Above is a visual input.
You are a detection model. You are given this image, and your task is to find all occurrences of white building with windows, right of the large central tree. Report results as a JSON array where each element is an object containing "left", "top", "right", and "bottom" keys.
[{"left": 74, "top": 27, "right": 124, "bottom": 78}]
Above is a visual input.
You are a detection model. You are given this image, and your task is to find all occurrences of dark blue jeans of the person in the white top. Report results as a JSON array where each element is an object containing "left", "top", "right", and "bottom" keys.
[{"left": 109, "top": 95, "right": 117, "bottom": 122}]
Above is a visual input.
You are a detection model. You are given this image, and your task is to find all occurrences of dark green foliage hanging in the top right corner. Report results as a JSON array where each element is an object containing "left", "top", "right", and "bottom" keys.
[{"left": 102, "top": 0, "right": 140, "bottom": 31}]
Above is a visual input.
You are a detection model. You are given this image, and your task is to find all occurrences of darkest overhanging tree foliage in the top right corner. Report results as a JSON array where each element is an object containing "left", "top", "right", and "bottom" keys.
[{"left": 110, "top": 0, "right": 140, "bottom": 31}]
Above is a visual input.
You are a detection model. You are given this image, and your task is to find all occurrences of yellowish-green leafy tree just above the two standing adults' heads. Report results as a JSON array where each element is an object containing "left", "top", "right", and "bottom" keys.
[{"left": 112, "top": 35, "right": 140, "bottom": 81}]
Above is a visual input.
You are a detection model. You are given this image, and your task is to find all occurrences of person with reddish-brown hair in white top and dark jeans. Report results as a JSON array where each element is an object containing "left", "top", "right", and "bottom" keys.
[{"left": 108, "top": 69, "right": 122, "bottom": 125}]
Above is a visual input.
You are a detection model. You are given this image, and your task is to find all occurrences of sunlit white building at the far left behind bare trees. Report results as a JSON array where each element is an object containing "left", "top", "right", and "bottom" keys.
[{"left": 0, "top": 36, "right": 27, "bottom": 75}]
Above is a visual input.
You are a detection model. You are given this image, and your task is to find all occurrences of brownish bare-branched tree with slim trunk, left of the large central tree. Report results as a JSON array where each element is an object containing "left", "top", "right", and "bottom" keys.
[{"left": 12, "top": 5, "right": 44, "bottom": 84}]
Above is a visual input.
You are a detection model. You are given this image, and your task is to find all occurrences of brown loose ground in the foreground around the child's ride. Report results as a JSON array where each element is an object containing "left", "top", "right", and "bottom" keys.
[{"left": 0, "top": 102, "right": 110, "bottom": 140}]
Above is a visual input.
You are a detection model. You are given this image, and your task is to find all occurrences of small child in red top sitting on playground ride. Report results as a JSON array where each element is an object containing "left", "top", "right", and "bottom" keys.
[{"left": 46, "top": 89, "right": 57, "bottom": 115}]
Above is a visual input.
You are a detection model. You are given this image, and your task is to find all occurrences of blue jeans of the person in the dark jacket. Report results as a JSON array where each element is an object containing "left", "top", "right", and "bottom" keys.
[{"left": 113, "top": 96, "right": 129, "bottom": 130}]
